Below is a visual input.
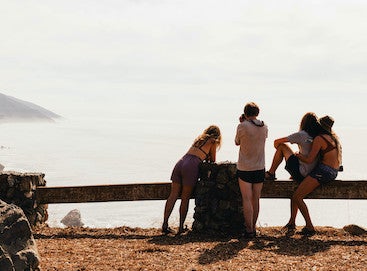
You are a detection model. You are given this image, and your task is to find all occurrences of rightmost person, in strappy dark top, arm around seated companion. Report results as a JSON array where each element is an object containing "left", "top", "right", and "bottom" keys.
[{"left": 284, "top": 116, "right": 342, "bottom": 235}]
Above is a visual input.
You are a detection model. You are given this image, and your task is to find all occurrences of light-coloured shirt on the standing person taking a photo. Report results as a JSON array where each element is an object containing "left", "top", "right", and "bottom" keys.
[{"left": 235, "top": 119, "right": 268, "bottom": 171}]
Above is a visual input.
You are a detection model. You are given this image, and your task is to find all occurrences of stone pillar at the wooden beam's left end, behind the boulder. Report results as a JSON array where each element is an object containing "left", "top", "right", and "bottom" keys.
[{"left": 0, "top": 171, "right": 48, "bottom": 227}]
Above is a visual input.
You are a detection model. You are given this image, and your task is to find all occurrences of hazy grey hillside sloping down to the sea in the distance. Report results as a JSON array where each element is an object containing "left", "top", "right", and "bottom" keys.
[{"left": 0, "top": 93, "right": 60, "bottom": 122}]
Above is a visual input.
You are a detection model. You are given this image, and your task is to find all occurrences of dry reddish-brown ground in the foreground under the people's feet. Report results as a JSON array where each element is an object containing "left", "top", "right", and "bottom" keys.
[{"left": 34, "top": 227, "right": 367, "bottom": 271}]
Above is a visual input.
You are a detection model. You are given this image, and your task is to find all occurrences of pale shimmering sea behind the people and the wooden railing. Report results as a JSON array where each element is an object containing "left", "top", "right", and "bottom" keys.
[{"left": 0, "top": 90, "right": 367, "bottom": 230}]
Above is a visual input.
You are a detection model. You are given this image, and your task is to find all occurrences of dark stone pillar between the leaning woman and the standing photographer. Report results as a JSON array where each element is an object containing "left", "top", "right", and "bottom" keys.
[{"left": 192, "top": 163, "right": 244, "bottom": 234}]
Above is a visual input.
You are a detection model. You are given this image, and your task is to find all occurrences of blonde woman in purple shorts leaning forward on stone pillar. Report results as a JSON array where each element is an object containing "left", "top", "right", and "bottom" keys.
[{"left": 162, "top": 125, "right": 222, "bottom": 234}]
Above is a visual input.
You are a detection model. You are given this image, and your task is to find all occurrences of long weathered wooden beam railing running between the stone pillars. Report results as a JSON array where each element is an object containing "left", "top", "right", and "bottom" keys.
[{"left": 36, "top": 181, "right": 367, "bottom": 204}]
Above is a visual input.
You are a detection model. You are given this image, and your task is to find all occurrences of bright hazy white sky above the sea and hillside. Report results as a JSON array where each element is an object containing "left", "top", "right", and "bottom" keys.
[{"left": 0, "top": 0, "right": 367, "bottom": 115}]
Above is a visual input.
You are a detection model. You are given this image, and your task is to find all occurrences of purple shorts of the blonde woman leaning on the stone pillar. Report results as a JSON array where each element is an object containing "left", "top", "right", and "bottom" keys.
[{"left": 171, "top": 154, "right": 201, "bottom": 186}]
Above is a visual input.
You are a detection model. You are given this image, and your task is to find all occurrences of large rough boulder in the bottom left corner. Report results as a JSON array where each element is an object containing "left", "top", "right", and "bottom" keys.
[{"left": 0, "top": 200, "right": 40, "bottom": 271}]
